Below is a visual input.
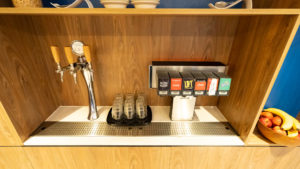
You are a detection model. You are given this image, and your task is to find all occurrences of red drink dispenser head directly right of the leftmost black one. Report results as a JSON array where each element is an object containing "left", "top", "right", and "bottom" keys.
[{"left": 169, "top": 71, "right": 182, "bottom": 96}]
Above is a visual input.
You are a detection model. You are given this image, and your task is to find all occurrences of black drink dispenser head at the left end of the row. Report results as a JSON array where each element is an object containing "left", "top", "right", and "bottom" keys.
[{"left": 157, "top": 71, "right": 170, "bottom": 96}]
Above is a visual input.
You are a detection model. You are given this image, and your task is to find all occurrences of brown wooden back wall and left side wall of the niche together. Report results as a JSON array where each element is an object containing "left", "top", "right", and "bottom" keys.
[{"left": 0, "top": 15, "right": 239, "bottom": 141}]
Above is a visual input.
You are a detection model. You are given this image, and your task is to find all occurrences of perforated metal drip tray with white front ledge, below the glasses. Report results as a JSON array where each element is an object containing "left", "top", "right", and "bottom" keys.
[{"left": 24, "top": 122, "right": 244, "bottom": 146}]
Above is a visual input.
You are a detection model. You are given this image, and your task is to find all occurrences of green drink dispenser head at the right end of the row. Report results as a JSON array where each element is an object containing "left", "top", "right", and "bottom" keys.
[{"left": 214, "top": 72, "right": 231, "bottom": 96}]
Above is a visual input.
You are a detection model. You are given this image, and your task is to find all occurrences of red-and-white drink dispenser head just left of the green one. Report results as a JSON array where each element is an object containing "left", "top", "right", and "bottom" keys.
[{"left": 203, "top": 72, "right": 219, "bottom": 96}]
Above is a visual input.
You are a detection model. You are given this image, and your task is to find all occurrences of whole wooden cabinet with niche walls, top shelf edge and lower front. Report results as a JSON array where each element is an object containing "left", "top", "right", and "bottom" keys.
[{"left": 0, "top": 8, "right": 300, "bottom": 169}]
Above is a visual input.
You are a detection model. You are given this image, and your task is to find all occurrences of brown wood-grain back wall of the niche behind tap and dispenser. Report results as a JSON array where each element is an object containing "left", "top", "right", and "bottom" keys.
[{"left": 32, "top": 16, "right": 238, "bottom": 105}]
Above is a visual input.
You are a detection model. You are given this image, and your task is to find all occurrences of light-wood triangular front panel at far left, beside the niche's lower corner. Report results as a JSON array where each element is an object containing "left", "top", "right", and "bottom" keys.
[{"left": 0, "top": 102, "right": 23, "bottom": 146}]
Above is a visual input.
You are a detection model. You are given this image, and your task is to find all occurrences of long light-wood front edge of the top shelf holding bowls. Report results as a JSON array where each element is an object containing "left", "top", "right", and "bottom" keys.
[{"left": 0, "top": 8, "right": 300, "bottom": 15}]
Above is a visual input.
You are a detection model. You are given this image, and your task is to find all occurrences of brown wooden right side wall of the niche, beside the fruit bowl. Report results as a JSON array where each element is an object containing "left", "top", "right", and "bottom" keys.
[{"left": 218, "top": 16, "right": 298, "bottom": 141}]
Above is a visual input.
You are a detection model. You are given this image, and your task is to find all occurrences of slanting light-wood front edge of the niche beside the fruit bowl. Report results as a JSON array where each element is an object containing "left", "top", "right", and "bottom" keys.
[{"left": 244, "top": 16, "right": 300, "bottom": 144}]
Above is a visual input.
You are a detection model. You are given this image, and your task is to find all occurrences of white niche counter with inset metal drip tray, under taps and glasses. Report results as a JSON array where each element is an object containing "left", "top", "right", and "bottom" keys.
[{"left": 24, "top": 106, "right": 244, "bottom": 146}]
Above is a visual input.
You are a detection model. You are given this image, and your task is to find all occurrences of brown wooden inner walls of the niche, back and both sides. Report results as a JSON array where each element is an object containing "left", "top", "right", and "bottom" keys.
[{"left": 0, "top": 15, "right": 297, "bottom": 141}]
